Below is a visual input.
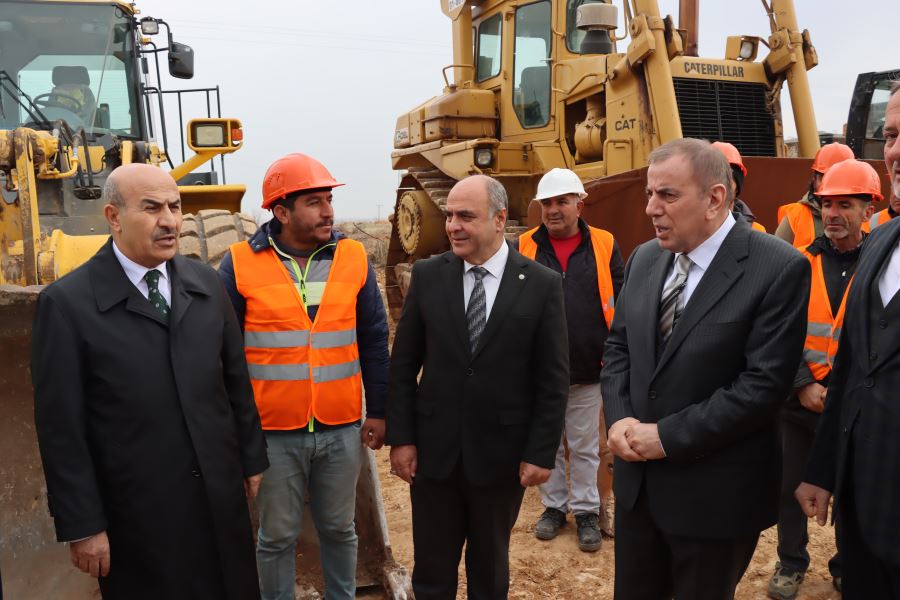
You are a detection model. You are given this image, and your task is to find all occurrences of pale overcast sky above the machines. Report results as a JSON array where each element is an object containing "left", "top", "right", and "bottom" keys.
[{"left": 138, "top": 0, "right": 900, "bottom": 220}]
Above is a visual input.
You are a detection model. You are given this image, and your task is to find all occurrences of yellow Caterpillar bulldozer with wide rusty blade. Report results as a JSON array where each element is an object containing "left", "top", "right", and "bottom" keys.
[{"left": 385, "top": 0, "right": 884, "bottom": 536}]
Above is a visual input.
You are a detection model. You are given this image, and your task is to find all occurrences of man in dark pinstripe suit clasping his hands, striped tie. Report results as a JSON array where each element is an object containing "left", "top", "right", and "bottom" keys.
[{"left": 601, "top": 139, "right": 810, "bottom": 600}]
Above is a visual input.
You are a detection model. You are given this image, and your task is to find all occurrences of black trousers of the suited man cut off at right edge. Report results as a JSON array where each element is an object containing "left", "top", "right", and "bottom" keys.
[{"left": 838, "top": 474, "right": 900, "bottom": 600}]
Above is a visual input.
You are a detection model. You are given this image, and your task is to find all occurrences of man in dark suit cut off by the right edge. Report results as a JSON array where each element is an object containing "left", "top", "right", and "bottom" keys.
[{"left": 796, "top": 84, "right": 900, "bottom": 600}]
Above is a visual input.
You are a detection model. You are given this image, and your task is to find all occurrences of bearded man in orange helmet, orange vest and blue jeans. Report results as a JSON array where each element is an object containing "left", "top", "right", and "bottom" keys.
[{"left": 219, "top": 154, "right": 388, "bottom": 600}]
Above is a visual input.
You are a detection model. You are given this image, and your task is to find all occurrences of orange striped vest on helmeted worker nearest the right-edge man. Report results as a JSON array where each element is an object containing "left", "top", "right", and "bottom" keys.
[{"left": 803, "top": 249, "right": 853, "bottom": 381}]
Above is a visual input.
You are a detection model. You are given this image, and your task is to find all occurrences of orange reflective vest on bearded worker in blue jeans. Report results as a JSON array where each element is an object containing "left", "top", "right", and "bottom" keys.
[{"left": 231, "top": 239, "right": 368, "bottom": 429}]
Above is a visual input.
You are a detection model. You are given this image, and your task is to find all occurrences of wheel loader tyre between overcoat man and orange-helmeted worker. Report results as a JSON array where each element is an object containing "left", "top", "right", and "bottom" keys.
[{"left": 178, "top": 210, "right": 257, "bottom": 269}]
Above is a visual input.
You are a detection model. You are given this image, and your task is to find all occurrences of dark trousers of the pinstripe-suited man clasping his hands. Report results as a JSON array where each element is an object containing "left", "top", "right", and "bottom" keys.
[{"left": 615, "top": 490, "right": 759, "bottom": 600}]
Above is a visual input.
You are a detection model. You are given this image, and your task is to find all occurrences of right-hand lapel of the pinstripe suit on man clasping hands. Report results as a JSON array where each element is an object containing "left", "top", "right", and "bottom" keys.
[{"left": 654, "top": 223, "right": 750, "bottom": 376}]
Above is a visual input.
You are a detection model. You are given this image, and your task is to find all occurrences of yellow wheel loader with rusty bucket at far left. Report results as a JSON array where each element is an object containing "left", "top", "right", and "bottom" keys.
[{"left": 0, "top": 0, "right": 409, "bottom": 600}]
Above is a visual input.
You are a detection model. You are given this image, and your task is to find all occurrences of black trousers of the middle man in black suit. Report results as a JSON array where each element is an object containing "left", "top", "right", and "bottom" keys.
[{"left": 410, "top": 465, "right": 525, "bottom": 600}]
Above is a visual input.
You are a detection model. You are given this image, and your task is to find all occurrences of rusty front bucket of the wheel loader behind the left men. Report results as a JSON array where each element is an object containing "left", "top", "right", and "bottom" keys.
[{"left": 0, "top": 285, "right": 412, "bottom": 600}]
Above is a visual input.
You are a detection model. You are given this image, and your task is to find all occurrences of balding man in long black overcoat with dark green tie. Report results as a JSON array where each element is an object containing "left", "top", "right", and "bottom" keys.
[{"left": 31, "top": 164, "right": 268, "bottom": 600}]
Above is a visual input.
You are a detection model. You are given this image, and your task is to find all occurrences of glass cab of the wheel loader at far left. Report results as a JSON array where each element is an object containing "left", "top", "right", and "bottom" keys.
[{"left": 0, "top": 0, "right": 144, "bottom": 139}]
